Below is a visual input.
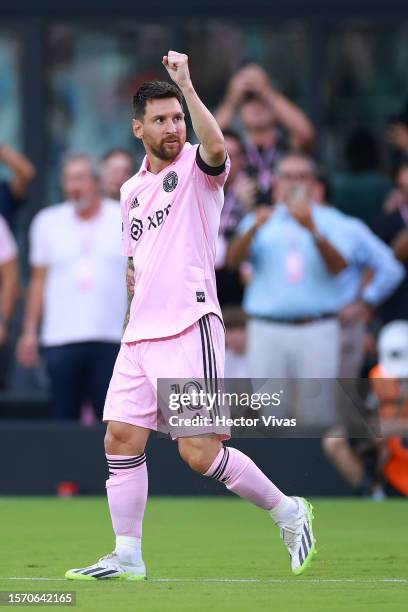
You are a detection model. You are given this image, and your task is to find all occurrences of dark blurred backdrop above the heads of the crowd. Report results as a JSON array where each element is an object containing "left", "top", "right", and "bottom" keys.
[{"left": 0, "top": 0, "right": 408, "bottom": 214}]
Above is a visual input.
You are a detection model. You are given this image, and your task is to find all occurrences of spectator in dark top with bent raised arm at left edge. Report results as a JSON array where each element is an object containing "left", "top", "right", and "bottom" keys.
[{"left": 0, "top": 143, "right": 35, "bottom": 229}]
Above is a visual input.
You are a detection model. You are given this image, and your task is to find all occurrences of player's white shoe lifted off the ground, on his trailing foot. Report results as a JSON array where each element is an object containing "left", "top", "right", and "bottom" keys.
[{"left": 277, "top": 497, "right": 317, "bottom": 576}]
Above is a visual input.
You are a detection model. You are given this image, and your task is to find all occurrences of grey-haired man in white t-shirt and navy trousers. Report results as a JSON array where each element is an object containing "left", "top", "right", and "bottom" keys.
[{"left": 17, "top": 155, "right": 126, "bottom": 419}]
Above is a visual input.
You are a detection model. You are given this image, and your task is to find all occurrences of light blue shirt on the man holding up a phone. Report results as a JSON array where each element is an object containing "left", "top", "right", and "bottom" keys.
[{"left": 238, "top": 203, "right": 354, "bottom": 322}]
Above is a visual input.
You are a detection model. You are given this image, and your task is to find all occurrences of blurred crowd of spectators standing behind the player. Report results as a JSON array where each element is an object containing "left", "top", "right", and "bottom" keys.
[{"left": 0, "top": 64, "right": 408, "bottom": 495}]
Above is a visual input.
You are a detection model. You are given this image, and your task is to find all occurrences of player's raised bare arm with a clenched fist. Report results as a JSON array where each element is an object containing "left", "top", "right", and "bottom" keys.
[{"left": 163, "top": 51, "right": 226, "bottom": 168}]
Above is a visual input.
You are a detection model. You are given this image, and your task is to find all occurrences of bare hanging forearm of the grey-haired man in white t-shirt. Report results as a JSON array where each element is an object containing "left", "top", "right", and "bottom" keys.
[{"left": 16, "top": 266, "right": 47, "bottom": 368}]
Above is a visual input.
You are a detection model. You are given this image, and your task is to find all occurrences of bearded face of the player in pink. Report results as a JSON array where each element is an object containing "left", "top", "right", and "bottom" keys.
[{"left": 135, "top": 98, "right": 186, "bottom": 161}]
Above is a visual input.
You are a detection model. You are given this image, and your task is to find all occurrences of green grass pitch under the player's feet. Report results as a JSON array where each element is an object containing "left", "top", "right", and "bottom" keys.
[{"left": 0, "top": 497, "right": 408, "bottom": 612}]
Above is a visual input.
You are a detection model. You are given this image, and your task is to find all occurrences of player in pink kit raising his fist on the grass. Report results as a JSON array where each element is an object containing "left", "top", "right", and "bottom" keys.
[{"left": 65, "top": 51, "right": 315, "bottom": 580}]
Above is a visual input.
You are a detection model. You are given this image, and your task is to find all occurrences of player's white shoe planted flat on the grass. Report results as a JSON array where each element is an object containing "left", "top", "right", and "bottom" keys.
[{"left": 65, "top": 552, "right": 147, "bottom": 580}]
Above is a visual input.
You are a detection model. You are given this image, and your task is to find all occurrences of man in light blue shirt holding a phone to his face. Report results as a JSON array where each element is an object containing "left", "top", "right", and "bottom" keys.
[{"left": 228, "top": 154, "right": 352, "bottom": 426}]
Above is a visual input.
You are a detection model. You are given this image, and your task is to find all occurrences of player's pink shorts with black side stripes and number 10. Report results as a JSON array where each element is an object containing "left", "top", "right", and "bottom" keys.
[{"left": 103, "top": 313, "right": 230, "bottom": 439}]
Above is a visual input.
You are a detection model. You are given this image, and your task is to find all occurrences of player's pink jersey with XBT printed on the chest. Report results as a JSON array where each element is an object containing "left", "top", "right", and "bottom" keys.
[{"left": 121, "top": 143, "right": 229, "bottom": 342}]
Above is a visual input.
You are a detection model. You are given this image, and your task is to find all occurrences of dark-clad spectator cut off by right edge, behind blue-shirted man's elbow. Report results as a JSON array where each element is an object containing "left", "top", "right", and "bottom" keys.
[{"left": 374, "top": 162, "right": 408, "bottom": 323}]
